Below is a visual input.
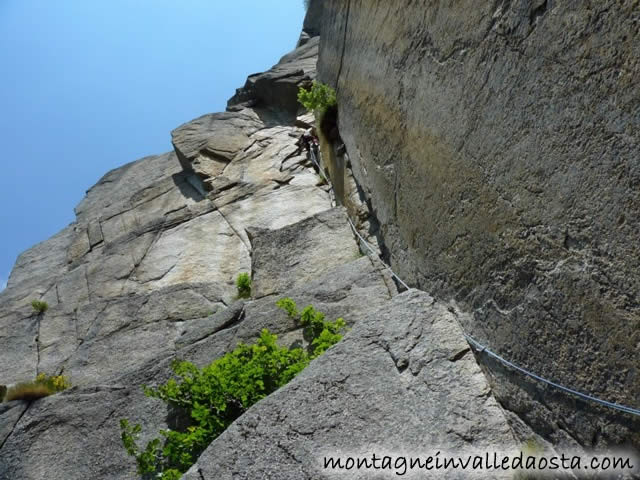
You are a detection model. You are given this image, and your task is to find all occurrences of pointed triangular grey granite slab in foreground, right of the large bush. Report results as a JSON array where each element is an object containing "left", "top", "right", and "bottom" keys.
[{"left": 184, "top": 290, "right": 518, "bottom": 480}]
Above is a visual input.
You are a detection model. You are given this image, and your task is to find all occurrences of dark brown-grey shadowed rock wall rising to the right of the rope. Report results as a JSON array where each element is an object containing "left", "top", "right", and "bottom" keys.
[{"left": 318, "top": 0, "right": 640, "bottom": 445}]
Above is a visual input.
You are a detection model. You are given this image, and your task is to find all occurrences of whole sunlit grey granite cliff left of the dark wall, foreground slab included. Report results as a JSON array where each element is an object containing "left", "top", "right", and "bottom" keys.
[{"left": 0, "top": 8, "right": 524, "bottom": 480}]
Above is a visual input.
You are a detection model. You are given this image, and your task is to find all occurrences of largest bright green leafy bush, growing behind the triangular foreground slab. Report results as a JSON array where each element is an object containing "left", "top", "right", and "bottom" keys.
[{"left": 120, "top": 298, "right": 345, "bottom": 480}]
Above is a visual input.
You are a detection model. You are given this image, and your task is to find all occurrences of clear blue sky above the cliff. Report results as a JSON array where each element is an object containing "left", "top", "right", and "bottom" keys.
[{"left": 0, "top": 0, "right": 304, "bottom": 289}]
